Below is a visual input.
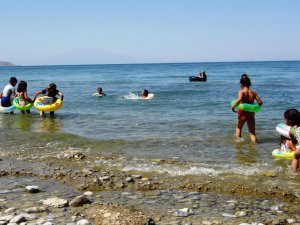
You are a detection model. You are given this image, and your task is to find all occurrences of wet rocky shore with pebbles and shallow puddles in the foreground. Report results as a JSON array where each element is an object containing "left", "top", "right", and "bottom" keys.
[{"left": 0, "top": 150, "right": 300, "bottom": 225}]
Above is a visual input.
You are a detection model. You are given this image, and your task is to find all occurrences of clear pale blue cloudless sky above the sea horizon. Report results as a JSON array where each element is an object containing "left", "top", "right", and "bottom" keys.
[{"left": 0, "top": 0, "right": 300, "bottom": 65}]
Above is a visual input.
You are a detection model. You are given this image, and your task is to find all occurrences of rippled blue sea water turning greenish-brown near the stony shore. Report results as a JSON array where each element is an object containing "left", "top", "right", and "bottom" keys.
[{"left": 0, "top": 61, "right": 300, "bottom": 178}]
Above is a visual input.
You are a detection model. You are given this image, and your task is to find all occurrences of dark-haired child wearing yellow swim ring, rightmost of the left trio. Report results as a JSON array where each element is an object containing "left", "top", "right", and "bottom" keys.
[{"left": 33, "top": 83, "right": 64, "bottom": 116}]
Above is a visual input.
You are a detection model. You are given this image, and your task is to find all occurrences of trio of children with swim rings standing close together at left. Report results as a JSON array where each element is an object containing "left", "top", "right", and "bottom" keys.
[{"left": 0, "top": 77, "right": 64, "bottom": 116}]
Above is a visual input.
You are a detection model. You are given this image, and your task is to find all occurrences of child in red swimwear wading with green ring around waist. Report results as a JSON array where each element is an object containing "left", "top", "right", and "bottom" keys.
[{"left": 231, "top": 74, "right": 262, "bottom": 143}]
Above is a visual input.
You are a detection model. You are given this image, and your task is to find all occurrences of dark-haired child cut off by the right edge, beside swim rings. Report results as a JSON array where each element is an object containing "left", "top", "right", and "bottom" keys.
[{"left": 284, "top": 109, "right": 300, "bottom": 173}]
